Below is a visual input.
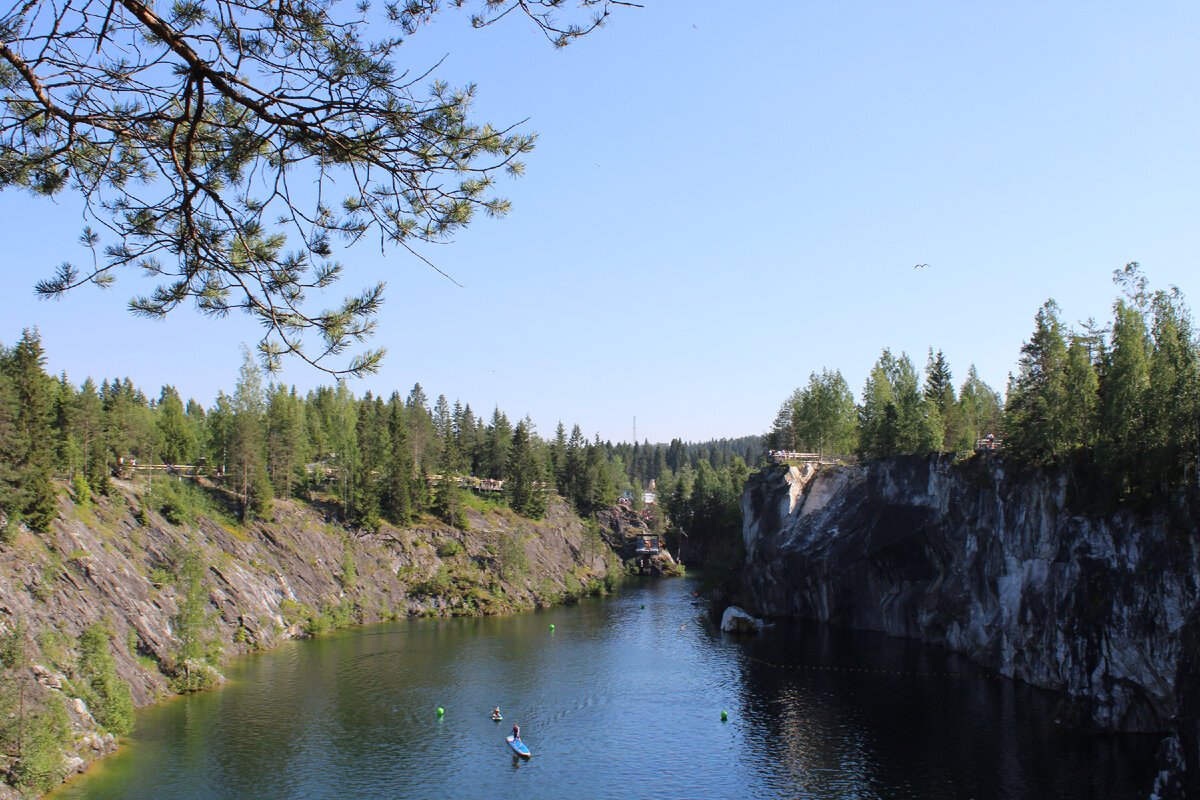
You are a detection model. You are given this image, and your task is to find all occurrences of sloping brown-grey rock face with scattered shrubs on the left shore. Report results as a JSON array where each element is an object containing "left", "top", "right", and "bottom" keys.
[{"left": 0, "top": 483, "right": 622, "bottom": 799}]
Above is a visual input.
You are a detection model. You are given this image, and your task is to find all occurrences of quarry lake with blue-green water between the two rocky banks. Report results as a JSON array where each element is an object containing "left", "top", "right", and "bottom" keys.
[{"left": 49, "top": 578, "right": 1157, "bottom": 800}]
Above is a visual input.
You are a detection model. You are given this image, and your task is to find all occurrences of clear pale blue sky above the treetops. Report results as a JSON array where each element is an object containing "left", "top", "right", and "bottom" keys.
[{"left": 0, "top": 0, "right": 1200, "bottom": 441}]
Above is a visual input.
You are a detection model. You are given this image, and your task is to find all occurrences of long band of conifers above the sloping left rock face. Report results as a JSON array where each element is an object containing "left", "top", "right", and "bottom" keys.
[{"left": 0, "top": 330, "right": 758, "bottom": 542}]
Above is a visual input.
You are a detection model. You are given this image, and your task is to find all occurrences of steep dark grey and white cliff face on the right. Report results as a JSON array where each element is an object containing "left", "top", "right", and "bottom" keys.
[{"left": 742, "top": 456, "right": 1200, "bottom": 796}]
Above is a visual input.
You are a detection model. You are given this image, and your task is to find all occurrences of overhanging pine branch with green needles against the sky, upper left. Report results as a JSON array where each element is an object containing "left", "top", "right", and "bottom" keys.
[{"left": 0, "top": 0, "right": 632, "bottom": 374}]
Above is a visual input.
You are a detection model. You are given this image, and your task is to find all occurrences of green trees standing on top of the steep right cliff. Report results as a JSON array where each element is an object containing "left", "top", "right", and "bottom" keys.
[{"left": 766, "top": 263, "right": 1200, "bottom": 505}]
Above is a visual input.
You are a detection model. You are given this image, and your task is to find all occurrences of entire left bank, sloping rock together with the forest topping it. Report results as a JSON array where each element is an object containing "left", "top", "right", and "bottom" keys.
[{"left": 0, "top": 340, "right": 760, "bottom": 796}]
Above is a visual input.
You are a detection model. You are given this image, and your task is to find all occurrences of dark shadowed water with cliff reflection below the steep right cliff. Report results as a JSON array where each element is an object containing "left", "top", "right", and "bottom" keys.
[{"left": 740, "top": 624, "right": 1157, "bottom": 800}]
